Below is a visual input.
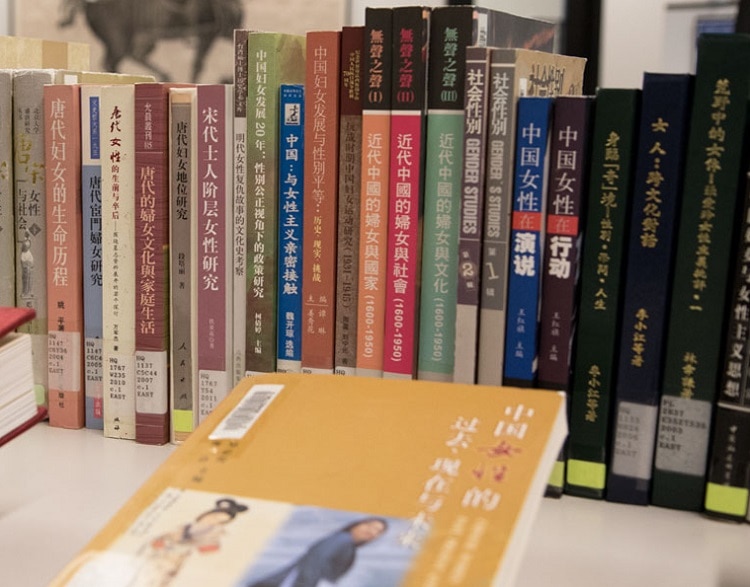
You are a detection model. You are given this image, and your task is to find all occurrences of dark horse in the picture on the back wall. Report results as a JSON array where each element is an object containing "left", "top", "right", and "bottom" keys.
[{"left": 84, "top": 0, "right": 243, "bottom": 82}]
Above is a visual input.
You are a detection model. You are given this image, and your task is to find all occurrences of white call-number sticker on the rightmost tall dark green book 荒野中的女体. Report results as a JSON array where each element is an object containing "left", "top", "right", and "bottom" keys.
[{"left": 655, "top": 396, "right": 711, "bottom": 476}]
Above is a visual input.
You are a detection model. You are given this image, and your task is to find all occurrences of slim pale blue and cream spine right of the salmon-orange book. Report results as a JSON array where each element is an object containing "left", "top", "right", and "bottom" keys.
[{"left": 81, "top": 85, "right": 104, "bottom": 430}]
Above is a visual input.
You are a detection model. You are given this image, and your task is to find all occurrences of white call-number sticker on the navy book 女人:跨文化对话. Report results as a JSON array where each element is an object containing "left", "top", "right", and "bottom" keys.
[{"left": 612, "top": 402, "right": 659, "bottom": 479}]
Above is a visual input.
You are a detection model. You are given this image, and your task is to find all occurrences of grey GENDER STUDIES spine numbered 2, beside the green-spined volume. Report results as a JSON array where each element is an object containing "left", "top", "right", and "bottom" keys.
[{"left": 453, "top": 47, "right": 490, "bottom": 384}]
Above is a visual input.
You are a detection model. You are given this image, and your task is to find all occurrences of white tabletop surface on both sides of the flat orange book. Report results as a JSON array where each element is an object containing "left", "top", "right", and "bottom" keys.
[{"left": 0, "top": 423, "right": 750, "bottom": 587}]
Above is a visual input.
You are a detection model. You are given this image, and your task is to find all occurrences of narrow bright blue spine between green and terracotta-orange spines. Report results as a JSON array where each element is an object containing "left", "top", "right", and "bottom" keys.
[{"left": 276, "top": 84, "right": 305, "bottom": 373}]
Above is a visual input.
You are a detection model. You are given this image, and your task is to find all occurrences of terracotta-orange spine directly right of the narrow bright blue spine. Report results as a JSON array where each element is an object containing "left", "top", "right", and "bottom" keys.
[{"left": 302, "top": 31, "right": 341, "bottom": 373}]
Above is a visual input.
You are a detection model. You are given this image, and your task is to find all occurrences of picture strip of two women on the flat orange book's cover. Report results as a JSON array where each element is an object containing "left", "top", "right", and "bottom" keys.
[{"left": 53, "top": 487, "right": 418, "bottom": 587}]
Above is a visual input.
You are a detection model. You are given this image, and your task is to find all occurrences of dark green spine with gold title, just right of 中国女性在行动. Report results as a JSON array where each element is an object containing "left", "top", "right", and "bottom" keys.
[{"left": 565, "top": 89, "right": 640, "bottom": 499}]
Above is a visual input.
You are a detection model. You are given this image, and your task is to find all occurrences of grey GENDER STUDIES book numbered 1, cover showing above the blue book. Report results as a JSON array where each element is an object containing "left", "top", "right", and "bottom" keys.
[{"left": 477, "top": 48, "right": 586, "bottom": 385}]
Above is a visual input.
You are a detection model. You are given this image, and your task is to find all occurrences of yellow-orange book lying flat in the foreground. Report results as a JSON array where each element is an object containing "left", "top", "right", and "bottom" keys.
[{"left": 54, "top": 374, "right": 567, "bottom": 587}]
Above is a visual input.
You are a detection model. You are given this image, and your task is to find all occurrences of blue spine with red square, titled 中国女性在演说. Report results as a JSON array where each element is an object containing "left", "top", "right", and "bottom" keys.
[{"left": 503, "top": 96, "right": 554, "bottom": 387}]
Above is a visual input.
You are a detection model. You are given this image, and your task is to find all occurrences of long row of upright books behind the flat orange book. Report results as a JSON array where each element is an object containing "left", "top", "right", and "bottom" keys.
[{"left": 2, "top": 7, "right": 748, "bottom": 517}]
